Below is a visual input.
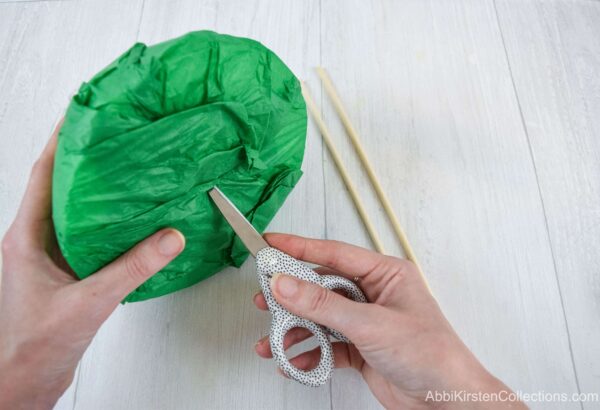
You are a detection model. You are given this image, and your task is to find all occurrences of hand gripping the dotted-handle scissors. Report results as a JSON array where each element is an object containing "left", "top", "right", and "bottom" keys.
[{"left": 254, "top": 234, "right": 525, "bottom": 409}]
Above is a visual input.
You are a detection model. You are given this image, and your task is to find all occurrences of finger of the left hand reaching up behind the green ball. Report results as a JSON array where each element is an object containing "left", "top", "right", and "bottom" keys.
[{"left": 15, "top": 119, "right": 63, "bottom": 246}]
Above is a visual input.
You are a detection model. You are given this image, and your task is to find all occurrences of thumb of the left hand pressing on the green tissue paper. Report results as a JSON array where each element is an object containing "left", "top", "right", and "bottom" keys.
[{"left": 78, "top": 229, "right": 185, "bottom": 306}]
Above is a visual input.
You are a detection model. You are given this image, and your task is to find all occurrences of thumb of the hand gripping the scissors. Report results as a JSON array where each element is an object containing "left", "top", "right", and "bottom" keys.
[{"left": 271, "top": 273, "right": 377, "bottom": 343}]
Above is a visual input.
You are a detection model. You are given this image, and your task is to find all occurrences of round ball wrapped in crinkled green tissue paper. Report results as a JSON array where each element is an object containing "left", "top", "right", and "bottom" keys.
[{"left": 53, "top": 31, "right": 306, "bottom": 302}]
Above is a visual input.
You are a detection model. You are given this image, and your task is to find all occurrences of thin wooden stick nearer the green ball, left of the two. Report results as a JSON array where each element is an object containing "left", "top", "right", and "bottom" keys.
[{"left": 302, "top": 83, "right": 385, "bottom": 253}]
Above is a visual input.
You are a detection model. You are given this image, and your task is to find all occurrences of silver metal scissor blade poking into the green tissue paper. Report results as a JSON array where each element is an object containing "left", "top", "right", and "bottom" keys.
[{"left": 208, "top": 187, "right": 269, "bottom": 256}]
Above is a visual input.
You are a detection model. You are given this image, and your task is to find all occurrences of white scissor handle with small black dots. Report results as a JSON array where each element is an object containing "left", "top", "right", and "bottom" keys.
[{"left": 256, "top": 247, "right": 367, "bottom": 387}]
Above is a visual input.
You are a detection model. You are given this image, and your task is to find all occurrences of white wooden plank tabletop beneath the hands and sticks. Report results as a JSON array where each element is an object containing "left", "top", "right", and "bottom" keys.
[{"left": 0, "top": 0, "right": 600, "bottom": 409}]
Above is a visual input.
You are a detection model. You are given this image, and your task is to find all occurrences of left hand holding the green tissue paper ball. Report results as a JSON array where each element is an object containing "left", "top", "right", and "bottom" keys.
[{"left": 0, "top": 120, "right": 185, "bottom": 410}]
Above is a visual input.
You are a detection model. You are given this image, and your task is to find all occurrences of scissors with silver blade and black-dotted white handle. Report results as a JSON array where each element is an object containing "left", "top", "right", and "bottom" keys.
[{"left": 208, "top": 187, "right": 367, "bottom": 387}]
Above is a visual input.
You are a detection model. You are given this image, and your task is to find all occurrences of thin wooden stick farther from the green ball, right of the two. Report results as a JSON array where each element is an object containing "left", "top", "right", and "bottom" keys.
[{"left": 316, "top": 67, "right": 429, "bottom": 286}]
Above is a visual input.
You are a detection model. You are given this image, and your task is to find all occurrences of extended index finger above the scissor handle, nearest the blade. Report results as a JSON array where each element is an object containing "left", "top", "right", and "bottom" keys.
[{"left": 265, "top": 233, "right": 387, "bottom": 279}]
